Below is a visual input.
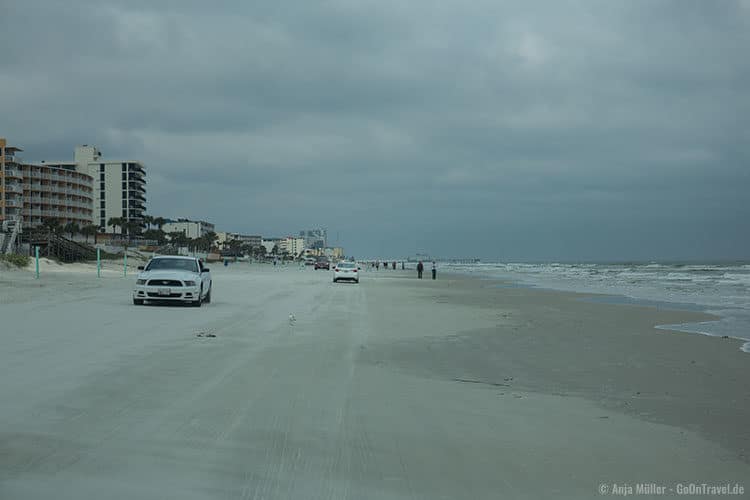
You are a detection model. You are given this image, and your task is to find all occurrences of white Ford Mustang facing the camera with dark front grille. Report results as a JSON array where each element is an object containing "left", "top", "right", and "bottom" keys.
[{"left": 133, "top": 255, "right": 211, "bottom": 307}]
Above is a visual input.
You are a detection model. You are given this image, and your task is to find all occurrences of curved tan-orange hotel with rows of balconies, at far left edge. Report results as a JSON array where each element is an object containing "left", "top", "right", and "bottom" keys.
[{"left": 0, "top": 138, "right": 93, "bottom": 227}]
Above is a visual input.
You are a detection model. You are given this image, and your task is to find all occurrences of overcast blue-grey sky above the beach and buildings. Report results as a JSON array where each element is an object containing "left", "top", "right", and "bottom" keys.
[{"left": 0, "top": 0, "right": 750, "bottom": 260}]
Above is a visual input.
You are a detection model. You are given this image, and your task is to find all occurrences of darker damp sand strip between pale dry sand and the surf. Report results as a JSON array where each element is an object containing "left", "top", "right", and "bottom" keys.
[{"left": 368, "top": 272, "right": 750, "bottom": 463}]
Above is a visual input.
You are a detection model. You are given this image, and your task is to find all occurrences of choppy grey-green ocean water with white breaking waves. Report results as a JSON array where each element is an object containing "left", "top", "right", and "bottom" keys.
[{"left": 441, "top": 262, "right": 750, "bottom": 353}]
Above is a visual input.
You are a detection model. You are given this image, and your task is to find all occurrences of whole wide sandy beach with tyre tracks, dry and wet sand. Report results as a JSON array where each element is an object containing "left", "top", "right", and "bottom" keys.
[{"left": 0, "top": 263, "right": 750, "bottom": 500}]
